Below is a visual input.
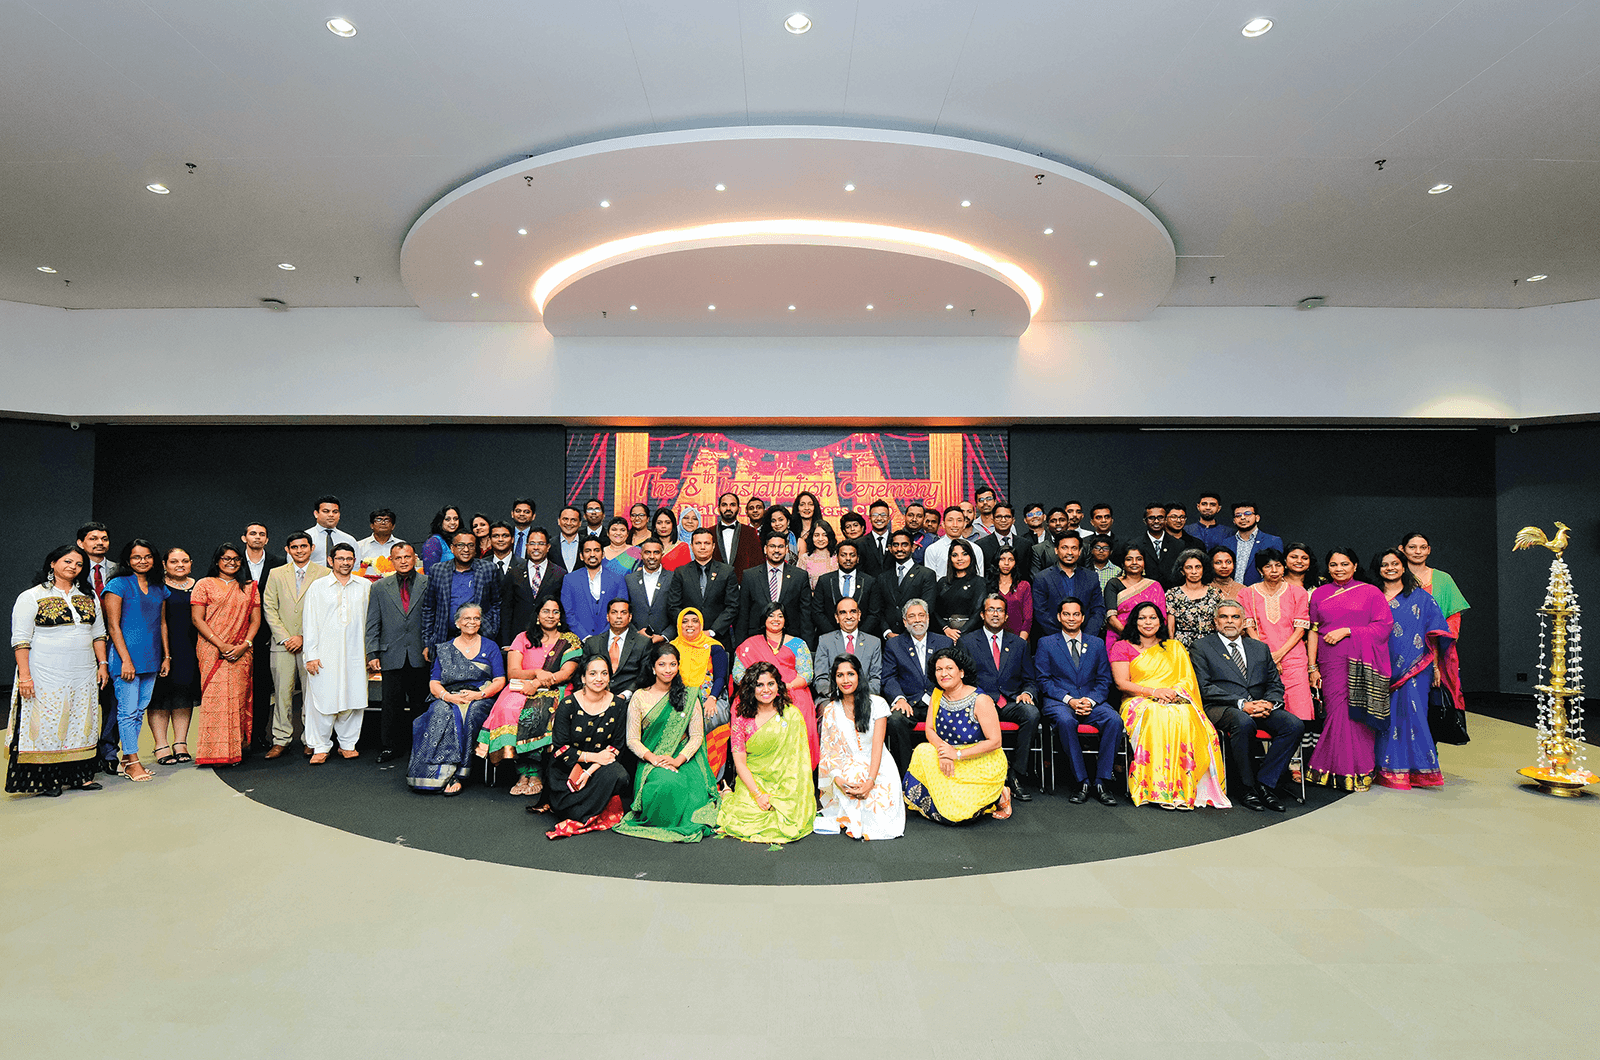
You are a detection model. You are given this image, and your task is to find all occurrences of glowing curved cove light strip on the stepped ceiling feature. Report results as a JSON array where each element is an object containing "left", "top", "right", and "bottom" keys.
[{"left": 533, "top": 221, "right": 1045, "bottom": 319}]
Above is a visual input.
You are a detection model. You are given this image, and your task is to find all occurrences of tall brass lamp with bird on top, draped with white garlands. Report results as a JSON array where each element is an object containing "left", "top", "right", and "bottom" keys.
[{"left": 1512, "top": 522, "right": 1597, "bottom": 796}]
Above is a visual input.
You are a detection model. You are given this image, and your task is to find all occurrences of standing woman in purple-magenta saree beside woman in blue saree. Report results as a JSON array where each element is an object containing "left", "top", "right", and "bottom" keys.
[{"left": 1307, "top": 548, "right": 1395, "bottom": 791}]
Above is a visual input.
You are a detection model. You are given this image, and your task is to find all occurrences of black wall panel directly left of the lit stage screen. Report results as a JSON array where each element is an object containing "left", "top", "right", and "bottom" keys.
[{"left": 94, "top": 426, "right": 566, "bottom": 573}]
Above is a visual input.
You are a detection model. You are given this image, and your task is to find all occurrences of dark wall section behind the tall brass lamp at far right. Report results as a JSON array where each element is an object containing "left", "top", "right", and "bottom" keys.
[{"left": 1494, "top": 424, "right": 1600, "bottom": 698}]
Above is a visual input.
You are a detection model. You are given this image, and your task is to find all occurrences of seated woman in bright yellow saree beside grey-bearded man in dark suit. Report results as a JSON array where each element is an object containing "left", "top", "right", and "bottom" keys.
[{"left": 1110, "top": 602, "right": 1232, "bottom": 810}]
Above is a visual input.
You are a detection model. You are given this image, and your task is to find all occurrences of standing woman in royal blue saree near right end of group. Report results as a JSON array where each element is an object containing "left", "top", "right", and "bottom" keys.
[{"left": 1373, "top": 549, "right": 1454, "bottom": 789}]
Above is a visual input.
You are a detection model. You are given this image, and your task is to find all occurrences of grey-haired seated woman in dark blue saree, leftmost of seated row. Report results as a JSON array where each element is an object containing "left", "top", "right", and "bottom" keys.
[{"left": 405, "top": 604, "right": 506, "bottom": 796}]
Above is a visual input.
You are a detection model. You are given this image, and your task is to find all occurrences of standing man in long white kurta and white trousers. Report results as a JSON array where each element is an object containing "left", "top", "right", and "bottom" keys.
[{"left": 301, "top": 543, "right": 373, "bottom": 765}]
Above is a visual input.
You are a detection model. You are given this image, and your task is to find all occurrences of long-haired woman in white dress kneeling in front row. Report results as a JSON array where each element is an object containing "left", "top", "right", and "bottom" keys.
[{"left": 816, "top": 652, "right": 906, "bottom": 839}]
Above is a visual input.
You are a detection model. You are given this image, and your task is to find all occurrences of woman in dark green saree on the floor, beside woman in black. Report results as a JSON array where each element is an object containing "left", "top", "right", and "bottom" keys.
[{"left": 616, "top": 642, "right": 717, "bottom": 842}]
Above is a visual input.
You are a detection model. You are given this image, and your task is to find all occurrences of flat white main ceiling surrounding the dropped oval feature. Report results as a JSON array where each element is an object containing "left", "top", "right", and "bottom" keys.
[{"left": 0, "top": 0, "right": 1600, "bottom": 307}]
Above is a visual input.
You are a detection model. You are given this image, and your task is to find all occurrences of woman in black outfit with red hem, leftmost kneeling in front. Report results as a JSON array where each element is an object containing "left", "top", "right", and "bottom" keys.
[{"left": 544, "top": 655, "right": 632, "bottom": 839}]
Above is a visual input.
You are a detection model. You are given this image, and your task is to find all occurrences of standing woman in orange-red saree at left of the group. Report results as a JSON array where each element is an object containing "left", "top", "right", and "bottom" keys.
[{"left": 189, "top": 544, "right": 261, "bottom": 765}]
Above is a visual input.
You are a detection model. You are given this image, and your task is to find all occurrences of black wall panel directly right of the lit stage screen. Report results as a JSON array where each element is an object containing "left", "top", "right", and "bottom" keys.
[{"left": 1011, "top": 428, "right": 1499, "bottom": 690}]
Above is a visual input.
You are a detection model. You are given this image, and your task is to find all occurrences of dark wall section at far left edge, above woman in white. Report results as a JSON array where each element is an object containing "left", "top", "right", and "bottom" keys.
[{"left": 0, "top": 420, "right": 94, "bottom": 602}]
